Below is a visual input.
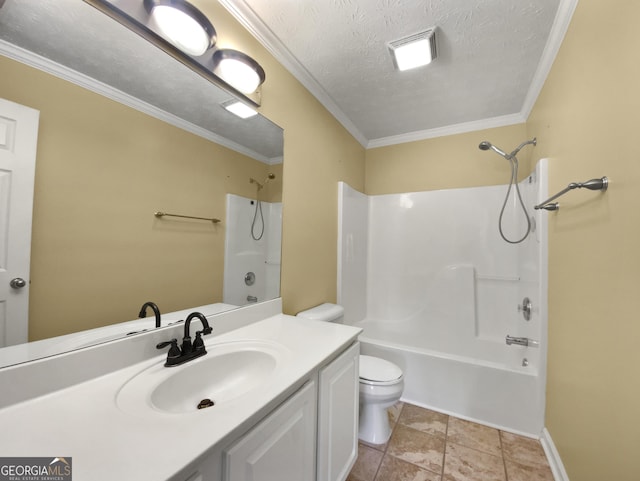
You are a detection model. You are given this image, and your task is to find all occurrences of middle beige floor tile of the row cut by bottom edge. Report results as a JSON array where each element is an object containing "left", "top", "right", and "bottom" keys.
[{"left": 443, "top": 442, "right": 506, "bottom": 481}]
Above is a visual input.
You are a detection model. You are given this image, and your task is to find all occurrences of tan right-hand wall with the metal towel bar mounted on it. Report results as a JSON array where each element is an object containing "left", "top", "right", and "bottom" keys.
[{"left": 527, "top": 0, "right": 640, "bottom": 481}]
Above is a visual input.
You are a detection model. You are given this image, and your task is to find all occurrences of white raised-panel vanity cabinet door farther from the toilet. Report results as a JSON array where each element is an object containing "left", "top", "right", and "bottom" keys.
[{"left": 223, "top": 381, "right": 316, "bottom": 481}]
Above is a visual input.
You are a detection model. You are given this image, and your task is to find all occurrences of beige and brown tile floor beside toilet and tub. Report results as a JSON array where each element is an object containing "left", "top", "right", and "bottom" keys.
[{"left": 347, "top": 403, "right": 554, "bottom": 481}]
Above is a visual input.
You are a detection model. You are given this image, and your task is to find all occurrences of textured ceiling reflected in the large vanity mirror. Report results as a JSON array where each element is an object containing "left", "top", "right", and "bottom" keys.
[{"left": 0, "top": 0, "right": 283, "bottom": 163}]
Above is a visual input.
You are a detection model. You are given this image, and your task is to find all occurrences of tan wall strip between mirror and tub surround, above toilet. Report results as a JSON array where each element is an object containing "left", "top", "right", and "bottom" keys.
[{"left": 202, "top": 2, "right": 365, "bottom": 314}]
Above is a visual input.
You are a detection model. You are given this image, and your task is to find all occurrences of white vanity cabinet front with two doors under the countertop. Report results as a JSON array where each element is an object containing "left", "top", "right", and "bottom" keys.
[{"left": 178, "top": 342, "right": 360, "bottom": 481}]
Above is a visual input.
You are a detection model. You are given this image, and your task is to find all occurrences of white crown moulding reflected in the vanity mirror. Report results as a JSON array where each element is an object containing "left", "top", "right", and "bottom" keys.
[{"left": 0, "top": 40, "right": 277, "bottom": 164}]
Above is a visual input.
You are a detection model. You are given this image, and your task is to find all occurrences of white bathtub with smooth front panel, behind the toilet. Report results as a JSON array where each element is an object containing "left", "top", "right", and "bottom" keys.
[{"left": 353, "top": 320, "right": 544, "bottom": 437}]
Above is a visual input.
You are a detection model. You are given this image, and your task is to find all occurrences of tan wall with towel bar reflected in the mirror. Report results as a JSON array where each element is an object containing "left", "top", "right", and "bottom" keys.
[{"left": 0, "top": 57, "right": 272, "bottom": 340}]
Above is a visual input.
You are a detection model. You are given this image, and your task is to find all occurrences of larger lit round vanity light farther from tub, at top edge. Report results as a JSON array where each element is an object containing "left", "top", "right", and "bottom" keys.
[{"left": 144, "top": 0, "right": 216, "bottom": 57}]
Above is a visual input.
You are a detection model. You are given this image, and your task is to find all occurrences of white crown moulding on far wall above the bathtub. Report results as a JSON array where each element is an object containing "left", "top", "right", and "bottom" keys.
[{"left": 366, "top": 114, "right": 527, "bottom": 149}]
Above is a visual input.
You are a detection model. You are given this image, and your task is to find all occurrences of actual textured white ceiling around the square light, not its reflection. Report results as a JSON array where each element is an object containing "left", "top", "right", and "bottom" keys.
[{"left": 218, "top": 0, "right": 572, "bottom": 146}]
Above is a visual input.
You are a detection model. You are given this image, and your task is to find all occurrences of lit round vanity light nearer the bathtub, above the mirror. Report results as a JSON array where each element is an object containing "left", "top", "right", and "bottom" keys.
[{"left": 212, "top": 48, "right": 265, "bottom": 94}]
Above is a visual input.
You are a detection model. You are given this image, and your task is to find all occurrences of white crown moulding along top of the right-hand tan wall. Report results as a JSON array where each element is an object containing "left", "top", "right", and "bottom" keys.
[{"left": 520, "top": 0, "right": 578, "bottom": 119}]
